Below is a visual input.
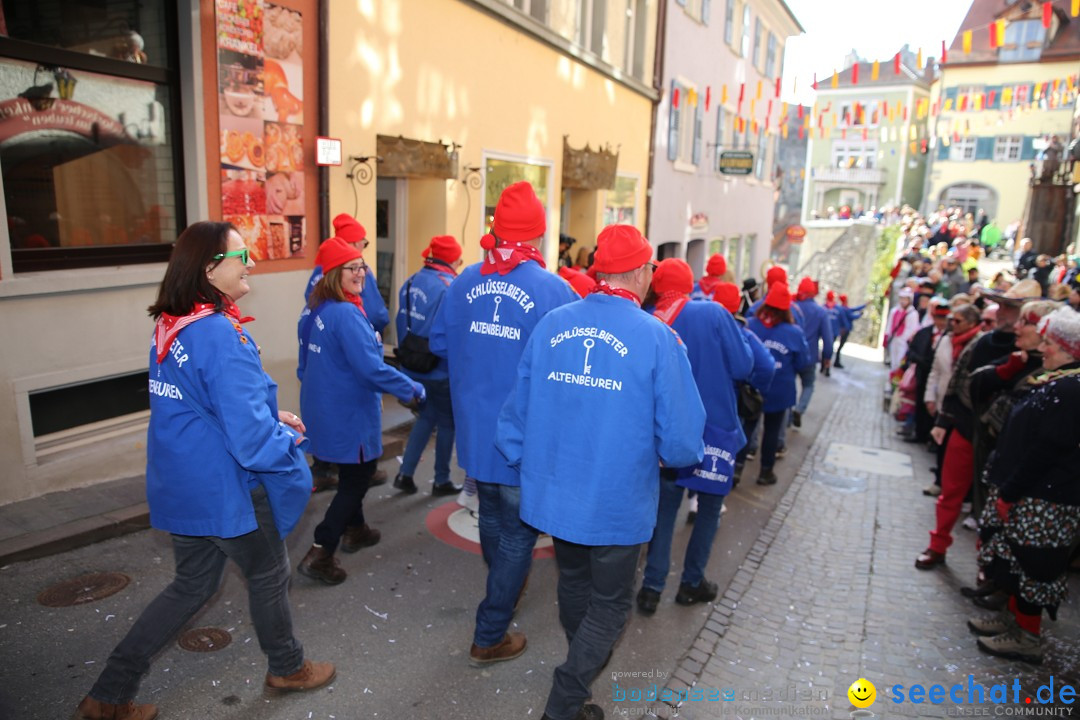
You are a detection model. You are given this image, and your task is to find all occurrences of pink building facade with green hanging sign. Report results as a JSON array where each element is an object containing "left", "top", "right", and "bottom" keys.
[{"left": 648, "top": 0, "right": 802, "bottom": 279}]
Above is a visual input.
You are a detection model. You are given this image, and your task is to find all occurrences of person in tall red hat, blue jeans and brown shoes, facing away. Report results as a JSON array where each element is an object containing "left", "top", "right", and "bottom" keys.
[{"left": 429, "top": 182, "right": 578, "bottom": 667}]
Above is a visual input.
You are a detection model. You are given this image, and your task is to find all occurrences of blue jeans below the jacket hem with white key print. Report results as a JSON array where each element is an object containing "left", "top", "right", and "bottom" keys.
[{"left": 642, "top": 471, "right": 724, "bottom": 593}]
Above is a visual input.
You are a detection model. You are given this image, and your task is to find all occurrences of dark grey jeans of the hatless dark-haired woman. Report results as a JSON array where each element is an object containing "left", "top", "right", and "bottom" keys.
[{"left": 90, "top": 488, "right": 303, "bottom": 705}]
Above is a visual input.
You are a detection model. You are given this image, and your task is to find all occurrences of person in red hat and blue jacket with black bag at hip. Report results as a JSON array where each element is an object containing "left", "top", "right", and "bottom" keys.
[{"left": 394, "top": 235, "right": 461, "bottom": 495}]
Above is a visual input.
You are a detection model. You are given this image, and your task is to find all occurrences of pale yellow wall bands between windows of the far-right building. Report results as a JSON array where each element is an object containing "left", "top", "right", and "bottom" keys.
[{"left": 926, "top": 62, "right": 1077, "bottom": 222}]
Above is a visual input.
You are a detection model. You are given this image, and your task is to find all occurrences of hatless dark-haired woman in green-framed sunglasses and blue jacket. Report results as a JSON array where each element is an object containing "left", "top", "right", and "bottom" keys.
[{"left": 75, "top": 222, "right": 335, "bottom": 720}]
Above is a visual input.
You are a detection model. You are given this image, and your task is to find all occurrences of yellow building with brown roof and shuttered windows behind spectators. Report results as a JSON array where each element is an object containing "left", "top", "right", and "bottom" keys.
[{"left": 924, "top": 0, "right": 1080, "bottom": 228}]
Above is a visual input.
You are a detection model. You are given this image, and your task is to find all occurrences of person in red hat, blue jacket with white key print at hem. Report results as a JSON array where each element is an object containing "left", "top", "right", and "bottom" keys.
[{"left": 637, "top": 258, "right": 751, "bottom": 614}]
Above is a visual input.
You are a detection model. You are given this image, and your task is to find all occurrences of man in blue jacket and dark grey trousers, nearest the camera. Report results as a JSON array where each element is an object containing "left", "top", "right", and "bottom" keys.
[{"left": 498, "top": 225, "right": 705, "bottom": 720}]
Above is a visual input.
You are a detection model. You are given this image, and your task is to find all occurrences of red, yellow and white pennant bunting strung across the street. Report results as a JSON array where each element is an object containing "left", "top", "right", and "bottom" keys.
[{"left": 671, "top": 0, "right": 1080, "bottom": 152}]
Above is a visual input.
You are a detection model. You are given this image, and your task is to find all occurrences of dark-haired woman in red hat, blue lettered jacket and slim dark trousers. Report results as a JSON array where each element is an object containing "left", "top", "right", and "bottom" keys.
[{"left": 746, "top": 282, "right": 813, "bottom": 485}]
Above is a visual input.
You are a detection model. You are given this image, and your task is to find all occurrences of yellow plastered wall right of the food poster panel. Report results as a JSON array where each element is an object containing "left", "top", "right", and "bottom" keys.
[{"left": 328, "top": 0, "right": 654, "bottom": 271}]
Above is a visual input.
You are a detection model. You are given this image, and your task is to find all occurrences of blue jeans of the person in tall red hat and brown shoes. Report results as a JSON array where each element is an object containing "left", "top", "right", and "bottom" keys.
[{"left": 473, "top": 481, "right": 540, "bottom": 648}]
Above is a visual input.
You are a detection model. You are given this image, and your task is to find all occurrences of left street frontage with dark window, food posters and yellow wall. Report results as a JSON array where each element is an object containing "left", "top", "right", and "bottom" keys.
[{"left": 0, "top": 0, "right": 658, "bottom": 503}]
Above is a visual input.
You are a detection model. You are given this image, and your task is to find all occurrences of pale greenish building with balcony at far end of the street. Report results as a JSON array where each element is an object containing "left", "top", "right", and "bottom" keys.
[{"left": 802, "top": 46, "right": 933, "bottom": 220}]
